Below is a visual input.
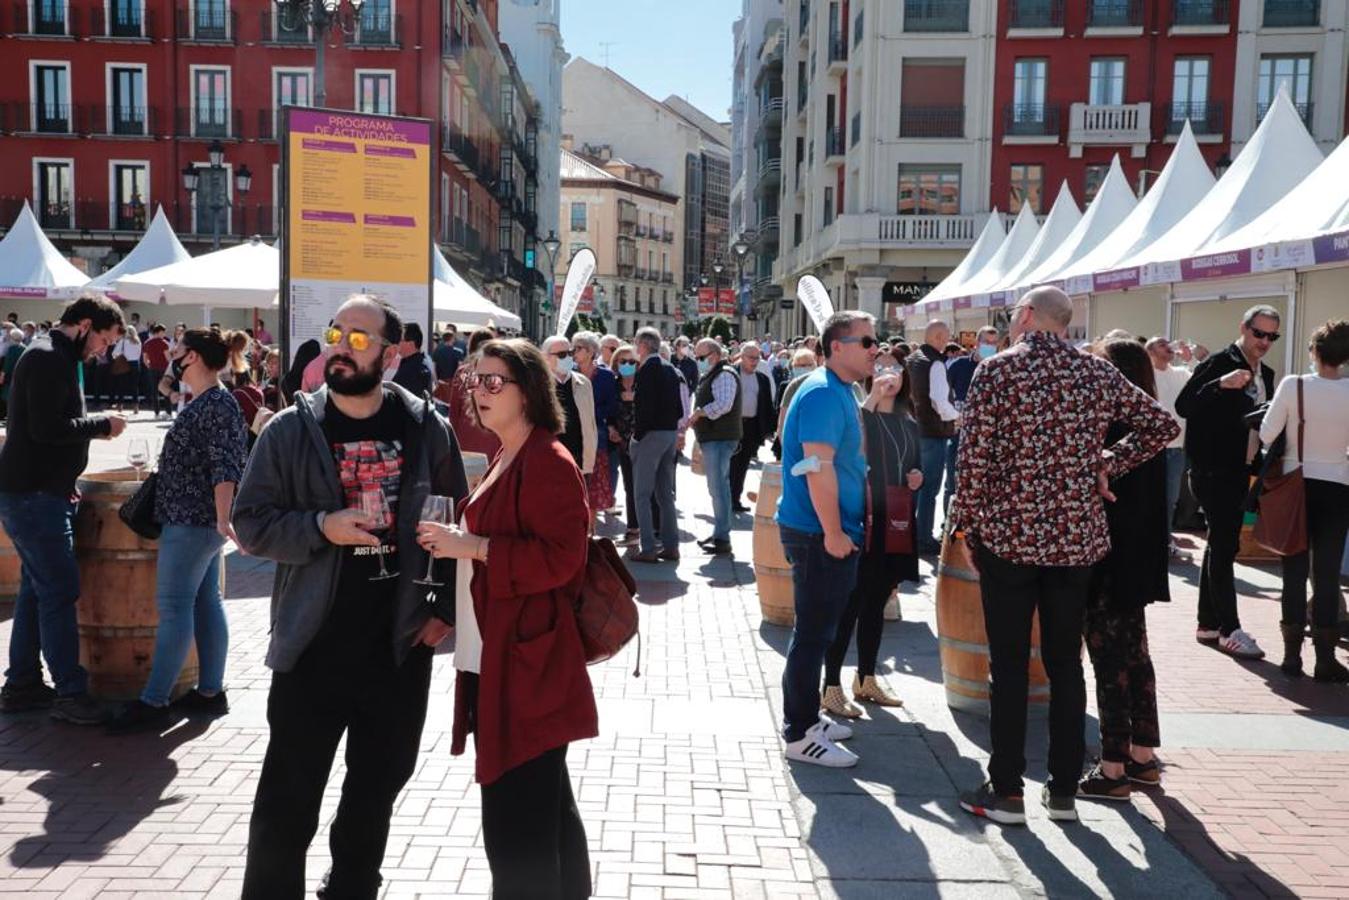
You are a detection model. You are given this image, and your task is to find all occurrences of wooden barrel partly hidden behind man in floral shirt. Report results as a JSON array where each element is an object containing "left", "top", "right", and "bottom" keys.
[{"left": 936, "top": 534, "right": 1050, "bottom": 715}]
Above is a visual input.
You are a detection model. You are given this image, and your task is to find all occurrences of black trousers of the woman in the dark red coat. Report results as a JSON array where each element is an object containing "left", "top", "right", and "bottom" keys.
[{"left": 482, "top": 746, "right": 591, "bottom": 900}]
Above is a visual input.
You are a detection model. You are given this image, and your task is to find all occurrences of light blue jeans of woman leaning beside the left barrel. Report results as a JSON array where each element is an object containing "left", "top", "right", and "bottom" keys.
[{"left": 140, "top": 525, "right": 229, "bottom": 706}]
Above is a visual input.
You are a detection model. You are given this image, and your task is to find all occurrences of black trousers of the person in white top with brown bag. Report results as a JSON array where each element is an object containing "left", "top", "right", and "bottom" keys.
[{"left": 1283, "top": 478, "right": 1349, "bottom": 627}]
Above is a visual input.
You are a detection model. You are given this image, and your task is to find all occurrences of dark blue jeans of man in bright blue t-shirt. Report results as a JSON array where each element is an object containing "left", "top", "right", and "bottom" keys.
[{"left": 777, "top": 525, "right": 861, "bottom": 743}]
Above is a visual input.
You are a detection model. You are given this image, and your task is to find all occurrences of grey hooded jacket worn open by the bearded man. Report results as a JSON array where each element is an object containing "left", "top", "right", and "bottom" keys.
[{"left": 233, "top": 383, "right": 468, "bottom": 672}]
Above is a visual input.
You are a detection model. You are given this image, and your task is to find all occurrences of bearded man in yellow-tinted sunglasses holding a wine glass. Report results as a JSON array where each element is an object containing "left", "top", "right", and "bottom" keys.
[{"left": 233, "top": 296, "right": 467, "bottom": 897}]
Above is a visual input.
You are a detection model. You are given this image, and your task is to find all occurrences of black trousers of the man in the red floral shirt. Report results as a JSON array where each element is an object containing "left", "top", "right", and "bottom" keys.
[{"left": 978, "top": 546, "right": 1091, "bottom": 795}]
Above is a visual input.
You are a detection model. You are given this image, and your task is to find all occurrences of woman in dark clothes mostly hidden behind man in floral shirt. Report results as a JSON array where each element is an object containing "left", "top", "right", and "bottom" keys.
[{"left": 1078, "top": 340, "right": 1171, "bottom": 800}]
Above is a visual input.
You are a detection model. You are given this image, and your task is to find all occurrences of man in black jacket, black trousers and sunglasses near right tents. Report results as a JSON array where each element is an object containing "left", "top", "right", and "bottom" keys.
[{"left": 1176, "top": 306, "right": 1279, "bottom": 658}]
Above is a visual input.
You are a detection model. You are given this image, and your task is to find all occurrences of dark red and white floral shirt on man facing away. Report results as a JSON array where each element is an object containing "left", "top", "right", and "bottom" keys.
[{"left": 951, "top": 332, "right": 1179, "bottom": 565}]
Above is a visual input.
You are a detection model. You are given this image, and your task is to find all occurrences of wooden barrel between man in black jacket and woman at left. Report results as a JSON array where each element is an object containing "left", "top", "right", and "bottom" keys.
[{"left": 74, "top": 471, "right": 196, "bottom": 700}]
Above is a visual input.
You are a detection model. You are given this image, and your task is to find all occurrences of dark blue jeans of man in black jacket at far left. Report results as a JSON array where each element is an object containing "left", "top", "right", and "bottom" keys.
[{"left": 0, "top": 491, "right": 89, "bottom": 696}]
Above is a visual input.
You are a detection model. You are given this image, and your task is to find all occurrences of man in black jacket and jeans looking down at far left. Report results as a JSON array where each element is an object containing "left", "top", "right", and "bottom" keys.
[{"left": 0, "top": 297, "right": 127, "bottom": 725}]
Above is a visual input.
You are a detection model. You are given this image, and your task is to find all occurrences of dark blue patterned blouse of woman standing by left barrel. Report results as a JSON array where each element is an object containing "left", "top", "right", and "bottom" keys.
[{"left": 155, "top": 386, "right": 248, "bottom": 528}]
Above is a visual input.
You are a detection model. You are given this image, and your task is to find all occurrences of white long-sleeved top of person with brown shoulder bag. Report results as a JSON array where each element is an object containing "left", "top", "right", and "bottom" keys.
[{"left": 1260, "top": 375, "right": 1349, "bottom": 484}]
